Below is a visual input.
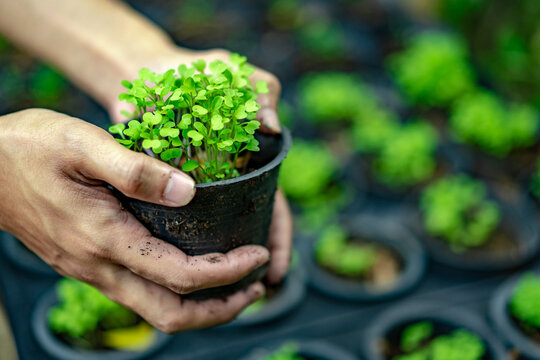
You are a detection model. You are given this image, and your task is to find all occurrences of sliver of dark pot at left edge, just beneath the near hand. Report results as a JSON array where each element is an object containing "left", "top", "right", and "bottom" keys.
[{"left": 0, "top": 232, "right": 59, "bottom": 277}]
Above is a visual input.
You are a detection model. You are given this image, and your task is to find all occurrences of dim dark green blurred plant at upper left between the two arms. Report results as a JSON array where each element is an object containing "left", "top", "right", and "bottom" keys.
[{"left": 30, "top": 65, "right": 68, "bottom": 107}]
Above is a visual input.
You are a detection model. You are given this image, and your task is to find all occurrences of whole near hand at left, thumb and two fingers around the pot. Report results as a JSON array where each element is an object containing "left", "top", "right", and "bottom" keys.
[{"left": 0, "top": 109, "right": 269, "bottom": 333}]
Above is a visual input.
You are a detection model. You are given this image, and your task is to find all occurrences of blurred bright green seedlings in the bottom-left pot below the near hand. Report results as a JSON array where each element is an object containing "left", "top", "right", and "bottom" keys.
[{"left": 48, "top": 278, "right": 137, "bottom": 344}]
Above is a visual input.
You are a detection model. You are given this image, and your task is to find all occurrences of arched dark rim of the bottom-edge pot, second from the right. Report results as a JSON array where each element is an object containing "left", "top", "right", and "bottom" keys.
[{"left": 363, "top": 301, "right": 507, "bottom": 360}]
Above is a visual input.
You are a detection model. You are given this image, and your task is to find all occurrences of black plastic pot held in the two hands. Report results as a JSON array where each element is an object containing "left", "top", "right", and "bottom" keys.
[{"left": 116, "top": 128, "right": 292, "bottom": 300}]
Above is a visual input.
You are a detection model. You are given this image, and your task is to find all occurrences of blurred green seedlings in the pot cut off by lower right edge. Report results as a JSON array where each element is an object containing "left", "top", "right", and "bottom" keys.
[{"left": 509, "top": 273, "right": 540, "bottom": 331}]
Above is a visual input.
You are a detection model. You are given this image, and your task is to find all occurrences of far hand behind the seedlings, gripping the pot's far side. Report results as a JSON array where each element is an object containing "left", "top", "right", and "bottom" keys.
[{"left": 107, "top": 48, "right": 292, "bottom": 283}]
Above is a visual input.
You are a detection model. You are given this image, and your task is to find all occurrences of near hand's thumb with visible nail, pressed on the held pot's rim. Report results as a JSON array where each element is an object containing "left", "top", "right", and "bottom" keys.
[{"left": 77, "top": 128, "right": 195, "bottom": 206}]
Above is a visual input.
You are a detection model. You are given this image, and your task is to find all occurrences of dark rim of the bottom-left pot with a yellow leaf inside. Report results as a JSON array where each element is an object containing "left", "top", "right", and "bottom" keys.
[{"left": 32, "top": 288, "right": 172, "bottom": 360}]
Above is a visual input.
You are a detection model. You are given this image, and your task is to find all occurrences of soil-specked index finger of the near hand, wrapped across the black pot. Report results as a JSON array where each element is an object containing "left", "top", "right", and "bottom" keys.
[{"left": 108, "top": 212, "right": 270, "bottom": 294}]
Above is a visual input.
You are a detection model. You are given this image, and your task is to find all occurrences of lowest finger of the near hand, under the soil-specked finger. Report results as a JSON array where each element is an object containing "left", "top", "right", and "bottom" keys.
[{"left": 100, "top": 267, "right": 264, "bottom": 333}]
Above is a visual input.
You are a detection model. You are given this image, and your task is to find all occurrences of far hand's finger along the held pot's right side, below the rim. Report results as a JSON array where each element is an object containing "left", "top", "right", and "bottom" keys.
[{"left": 267, "top": 190, "right": 293, "bottom": 284}]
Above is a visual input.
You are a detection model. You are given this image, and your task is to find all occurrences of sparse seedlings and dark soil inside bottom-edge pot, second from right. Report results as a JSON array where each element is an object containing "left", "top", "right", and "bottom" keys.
[{"left": 381, "top": 321, "right": 491, "bottom": 360}]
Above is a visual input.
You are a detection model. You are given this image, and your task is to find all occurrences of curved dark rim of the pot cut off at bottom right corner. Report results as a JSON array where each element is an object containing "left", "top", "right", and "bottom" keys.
[{"left": 489, "top": 271, "right": 540, "bottom": 360}]
